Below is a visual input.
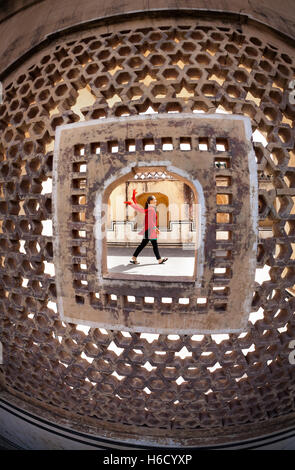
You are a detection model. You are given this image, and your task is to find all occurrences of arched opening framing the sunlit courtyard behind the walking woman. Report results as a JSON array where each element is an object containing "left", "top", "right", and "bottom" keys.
[{"left": 106, "top": 167, "right": 200, "bottom": 281}]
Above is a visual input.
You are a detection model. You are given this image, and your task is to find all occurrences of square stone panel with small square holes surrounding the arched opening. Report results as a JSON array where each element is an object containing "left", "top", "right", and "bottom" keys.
[{"left": 53, "top": 114, "right": 258, "bottom": 333}]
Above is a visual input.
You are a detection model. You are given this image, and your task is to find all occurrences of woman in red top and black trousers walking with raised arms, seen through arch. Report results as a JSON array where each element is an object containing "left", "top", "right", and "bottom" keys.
[{"left": 125, "top": 189, "right": 168, "bottom": 264}]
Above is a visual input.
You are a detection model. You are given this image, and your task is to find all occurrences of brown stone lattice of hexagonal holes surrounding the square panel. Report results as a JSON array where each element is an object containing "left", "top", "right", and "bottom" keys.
[{"left": 0, "top": 18, "right": 295, "bottom": 445}]
